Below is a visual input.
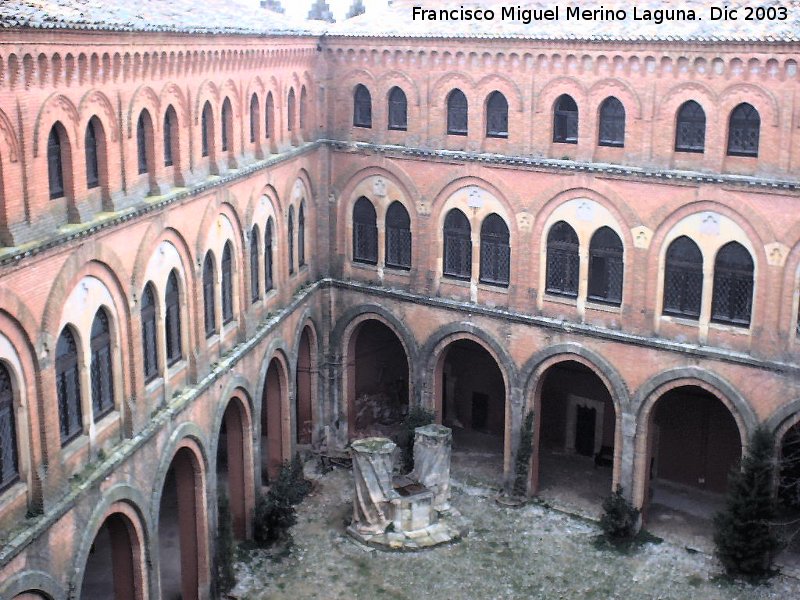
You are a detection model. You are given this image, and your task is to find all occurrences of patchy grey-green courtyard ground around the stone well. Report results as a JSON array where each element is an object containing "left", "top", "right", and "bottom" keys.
[{"left": 232, "top": 452, "right": 800, "bottom": 600}]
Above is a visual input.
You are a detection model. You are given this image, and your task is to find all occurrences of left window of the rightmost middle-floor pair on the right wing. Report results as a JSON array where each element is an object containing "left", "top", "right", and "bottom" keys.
[{"left": 663, "top": 235, "right": 703, "bottom": 319}]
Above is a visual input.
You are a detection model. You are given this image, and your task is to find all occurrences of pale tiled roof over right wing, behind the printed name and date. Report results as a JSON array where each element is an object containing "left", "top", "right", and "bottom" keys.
[{"left": 326, "top": 0, "right": 800, "bottom": 42}]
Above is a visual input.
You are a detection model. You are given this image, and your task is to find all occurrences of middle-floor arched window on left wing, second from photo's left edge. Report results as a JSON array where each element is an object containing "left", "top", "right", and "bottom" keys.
[{"left": 56, "top": 327, "right": 83, "bottom": 446}]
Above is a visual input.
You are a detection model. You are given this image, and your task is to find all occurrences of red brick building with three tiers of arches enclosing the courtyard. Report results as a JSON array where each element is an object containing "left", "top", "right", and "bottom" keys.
[{"left": 0, "top": 0, "right": 800, "bottom": 599}]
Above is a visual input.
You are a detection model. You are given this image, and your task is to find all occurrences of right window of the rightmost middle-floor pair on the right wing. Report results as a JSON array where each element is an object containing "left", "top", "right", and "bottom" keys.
[{"left": 711, "top": 242, "right": 753, "bottom": 327}]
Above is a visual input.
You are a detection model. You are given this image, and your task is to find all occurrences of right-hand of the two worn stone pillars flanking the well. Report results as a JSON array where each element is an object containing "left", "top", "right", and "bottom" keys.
[{"left": 409, "top": 424, "right": 453, "bottom": 511}]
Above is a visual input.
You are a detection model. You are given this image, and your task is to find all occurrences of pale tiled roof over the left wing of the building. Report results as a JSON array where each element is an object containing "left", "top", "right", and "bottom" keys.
[{"left": 0, "top": 0, "right": 323, "bottom": 35}]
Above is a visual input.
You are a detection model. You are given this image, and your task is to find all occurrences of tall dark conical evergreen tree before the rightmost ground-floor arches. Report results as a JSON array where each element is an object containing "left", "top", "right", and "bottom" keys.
[{"left": 714, "top": 426, "right": 779, "bottom": 577}]
